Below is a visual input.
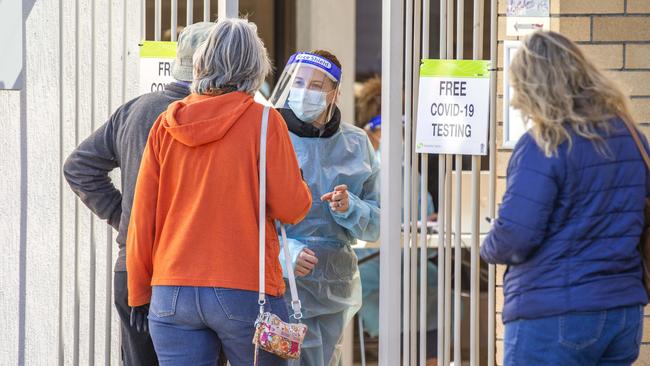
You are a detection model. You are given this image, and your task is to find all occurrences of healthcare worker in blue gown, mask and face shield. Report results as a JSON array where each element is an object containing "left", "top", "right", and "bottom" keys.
[{"left": 270, "top": 51, "right": 379, "bottom": 366}]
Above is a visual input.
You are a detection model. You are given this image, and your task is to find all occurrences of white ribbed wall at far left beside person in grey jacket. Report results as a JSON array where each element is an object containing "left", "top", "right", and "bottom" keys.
[{"left": 0, "top": 0, "right": 140, "bottom": 365}]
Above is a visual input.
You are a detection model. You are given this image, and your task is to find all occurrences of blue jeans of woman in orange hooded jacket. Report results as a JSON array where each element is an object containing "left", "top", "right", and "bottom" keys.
[{"left": 149, "top": 286, "right": 289, "bottom": 366}]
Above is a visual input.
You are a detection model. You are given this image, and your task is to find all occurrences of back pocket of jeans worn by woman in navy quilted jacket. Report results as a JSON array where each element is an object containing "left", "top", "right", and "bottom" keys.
[{"left": 559, "top": 311, "right": 607, "bottom": 350}]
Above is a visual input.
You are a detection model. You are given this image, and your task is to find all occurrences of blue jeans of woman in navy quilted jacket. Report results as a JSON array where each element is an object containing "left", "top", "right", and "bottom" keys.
[{"left": 504, "top": 305, "right": 643, "bottom": 366}]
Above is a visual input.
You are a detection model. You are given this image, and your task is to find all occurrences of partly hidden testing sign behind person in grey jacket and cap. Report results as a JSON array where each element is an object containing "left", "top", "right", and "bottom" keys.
[{"left": 139, "top": 41, "right": 176, "bottom": 94}]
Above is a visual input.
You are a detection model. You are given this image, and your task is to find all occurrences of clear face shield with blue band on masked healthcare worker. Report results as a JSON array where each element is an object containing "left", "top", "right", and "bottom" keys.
[{"left": 269, "top": 52, "right": 341, "bottom": 125}]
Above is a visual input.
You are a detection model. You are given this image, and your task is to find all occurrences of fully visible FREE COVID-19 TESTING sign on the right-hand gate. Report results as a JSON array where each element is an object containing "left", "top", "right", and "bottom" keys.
[{"left": 415, "top": 60, "right": 490, "bottom": 155}]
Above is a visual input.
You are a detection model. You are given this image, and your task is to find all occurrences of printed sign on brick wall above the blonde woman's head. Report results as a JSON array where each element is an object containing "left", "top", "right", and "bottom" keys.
[{"left": 506, "top": 0, "right": 551, "bottom": 36}]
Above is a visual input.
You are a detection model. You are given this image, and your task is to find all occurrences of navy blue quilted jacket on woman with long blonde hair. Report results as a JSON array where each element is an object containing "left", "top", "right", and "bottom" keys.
[{"left": 481, "top": 119, "right": 650, "bottom": 322}]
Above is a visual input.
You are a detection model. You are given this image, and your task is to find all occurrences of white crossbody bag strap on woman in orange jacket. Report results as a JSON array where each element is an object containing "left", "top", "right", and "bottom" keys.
[{"left": 258, "top": 107, "right": 302, "bottom": 319}]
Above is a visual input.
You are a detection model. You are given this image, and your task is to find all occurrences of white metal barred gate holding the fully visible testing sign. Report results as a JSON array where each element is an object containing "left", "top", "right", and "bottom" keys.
[{"left": 379, "top": 0, "right": 497, "bottom": 365}]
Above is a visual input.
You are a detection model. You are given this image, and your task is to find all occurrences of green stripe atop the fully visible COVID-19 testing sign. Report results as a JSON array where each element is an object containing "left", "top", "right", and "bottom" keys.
[{"left": 420, "top": 60, "right": 490, "bottom": 78}]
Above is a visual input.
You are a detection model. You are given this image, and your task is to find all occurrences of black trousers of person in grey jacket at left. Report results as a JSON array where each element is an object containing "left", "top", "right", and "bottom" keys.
[{"left": 113, "top": 272, "right": 158, "bottom": 366}]
